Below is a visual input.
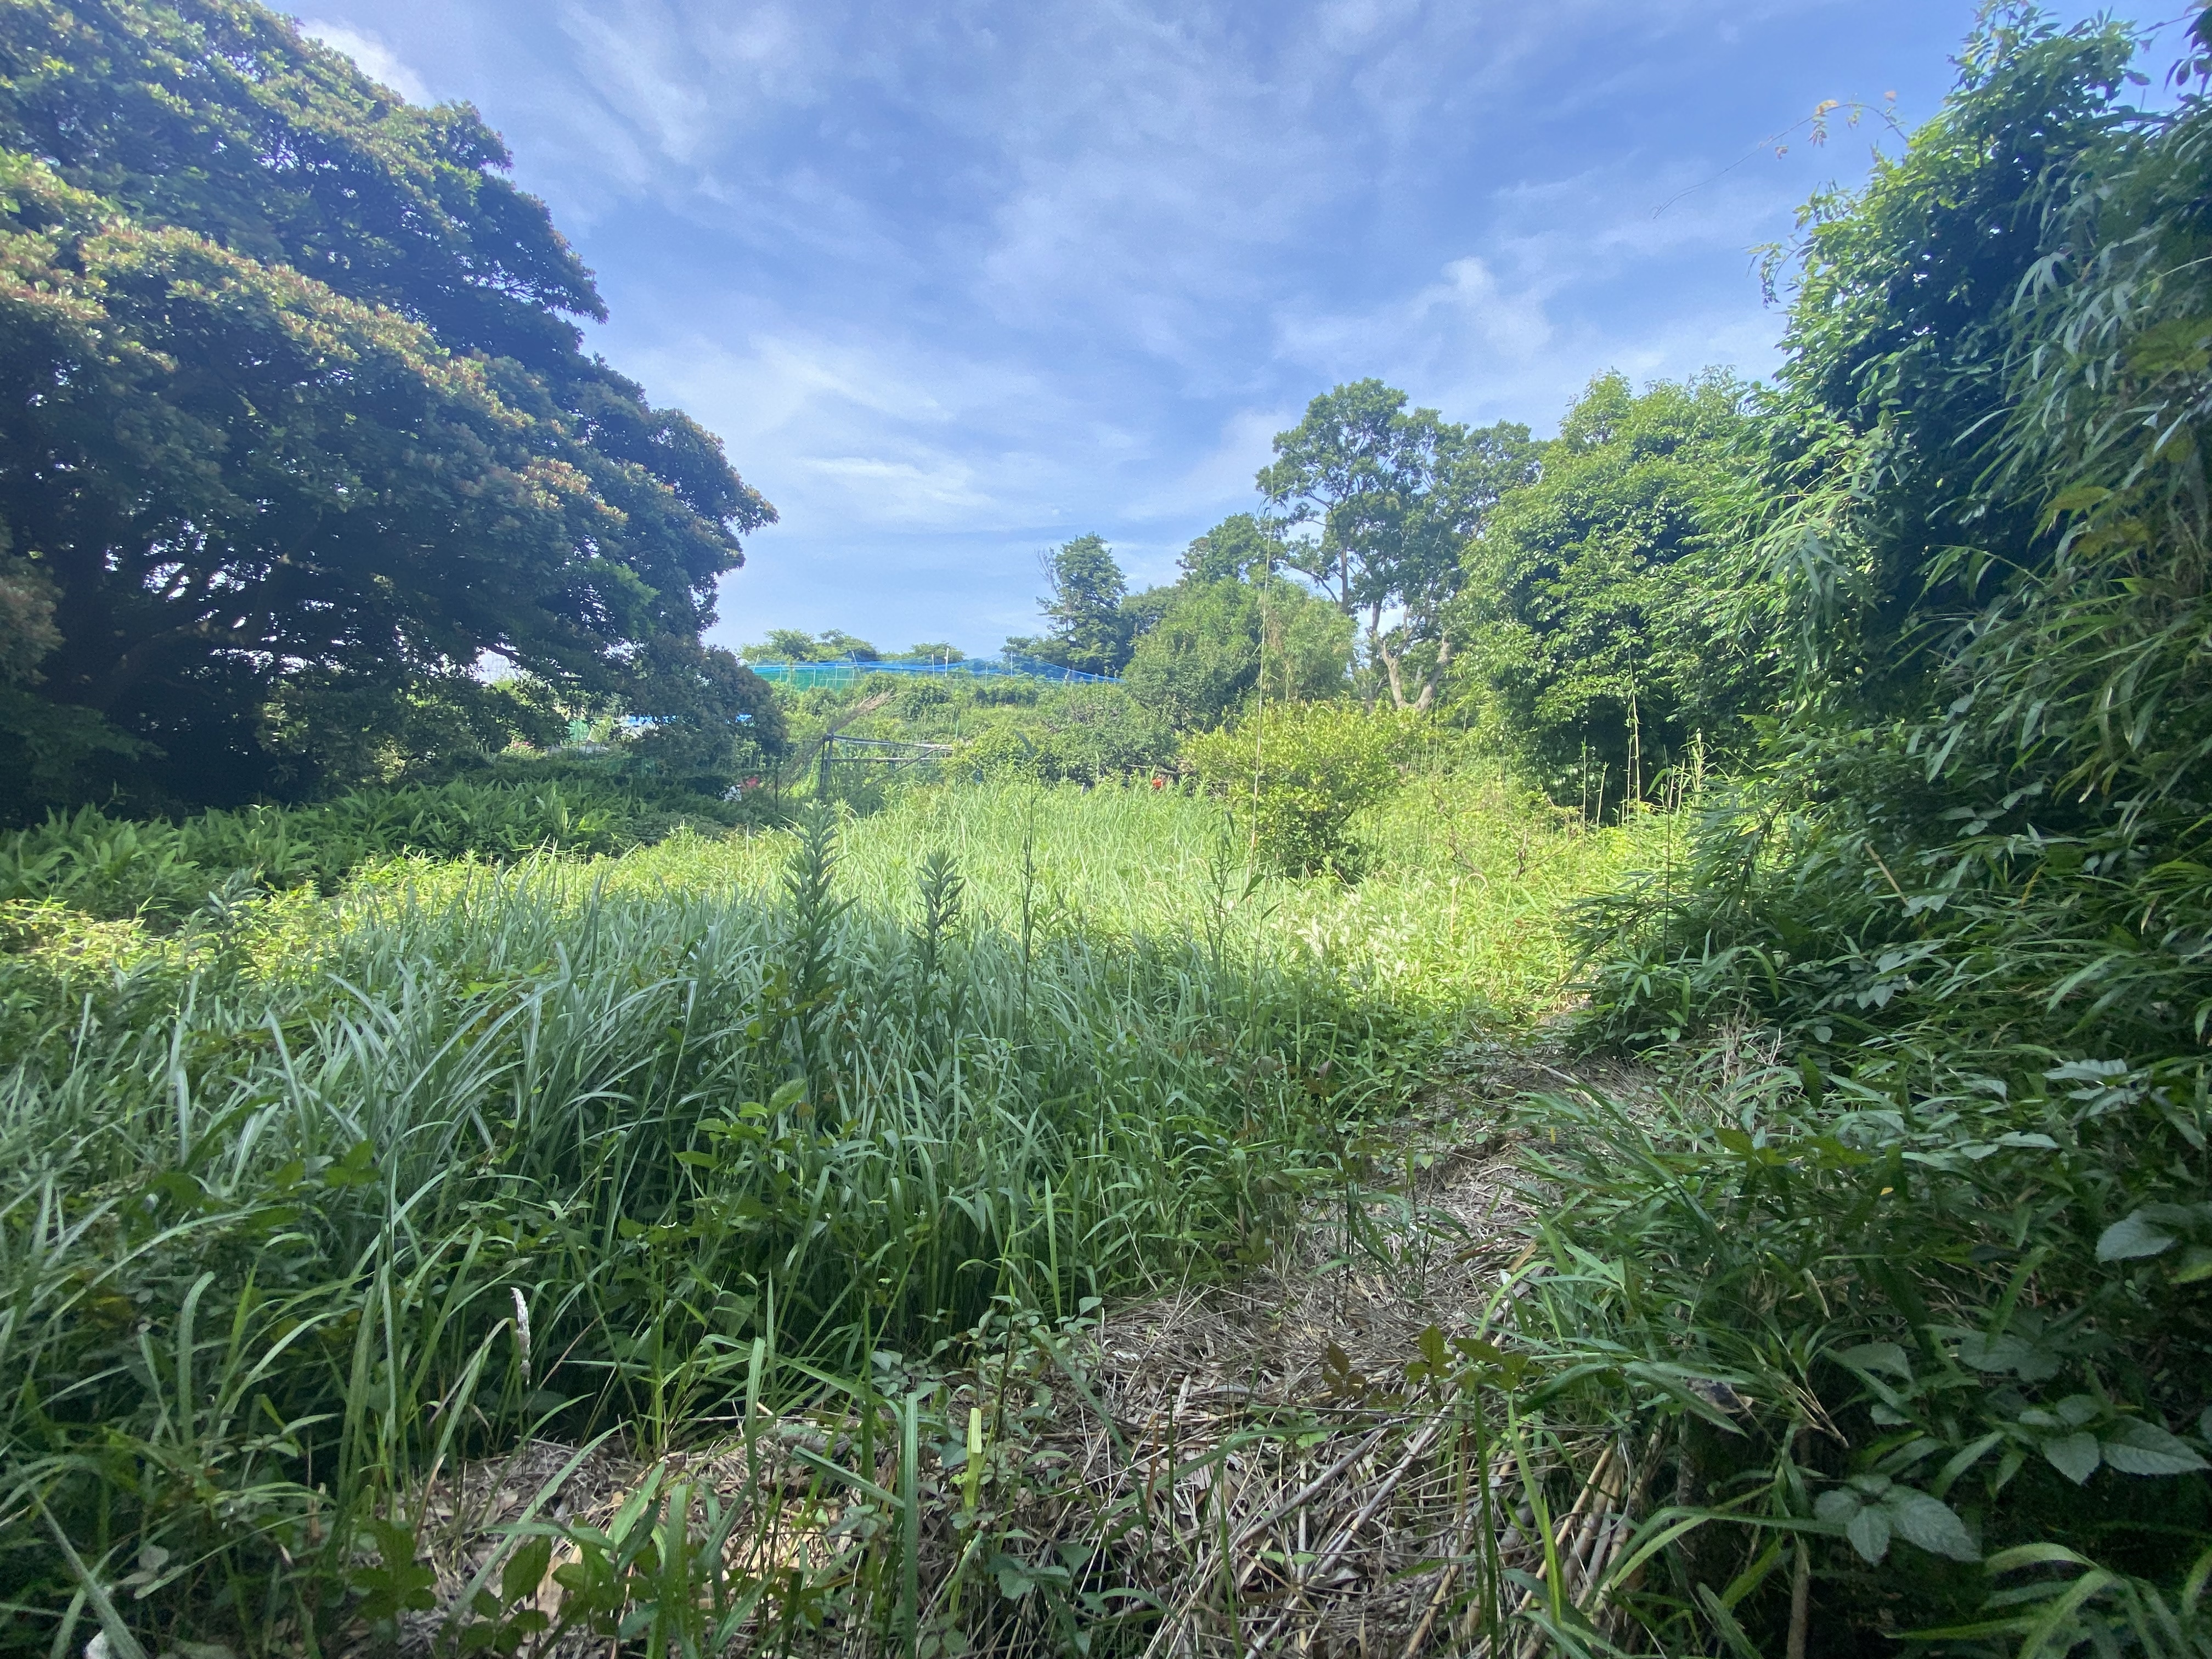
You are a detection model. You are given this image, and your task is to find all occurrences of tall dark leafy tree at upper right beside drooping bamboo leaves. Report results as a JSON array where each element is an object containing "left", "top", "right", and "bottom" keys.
[{"left": 1732, "top": 7, "right": 2141, "bottom": 719}]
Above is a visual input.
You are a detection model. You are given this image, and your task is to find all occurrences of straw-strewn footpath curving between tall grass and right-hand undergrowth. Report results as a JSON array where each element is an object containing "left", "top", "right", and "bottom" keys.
[{"left": 995, "top": 1051, "right": 1648, "bottom": 1659}]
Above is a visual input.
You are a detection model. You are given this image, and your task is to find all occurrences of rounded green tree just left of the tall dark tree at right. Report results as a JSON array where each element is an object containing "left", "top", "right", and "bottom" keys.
[{"left": 1453, "top": 374, "right": 1772, "bottom": 801}]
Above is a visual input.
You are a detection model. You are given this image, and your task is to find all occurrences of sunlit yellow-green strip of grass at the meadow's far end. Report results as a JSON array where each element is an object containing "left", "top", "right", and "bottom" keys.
[{"left": 449, "top": 770, "right": 1668, "bottom": 1024}]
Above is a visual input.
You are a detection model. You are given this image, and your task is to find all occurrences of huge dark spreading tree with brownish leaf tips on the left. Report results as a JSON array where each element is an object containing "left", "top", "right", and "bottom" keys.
[{"left": 0, "top": 0, "right": 774, "bottom": 801}]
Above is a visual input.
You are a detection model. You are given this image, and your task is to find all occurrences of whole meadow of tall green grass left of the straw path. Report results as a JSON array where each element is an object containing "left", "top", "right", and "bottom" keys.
[{"left": 0, "top": 776, "right": 1648, "bottom": 1659}]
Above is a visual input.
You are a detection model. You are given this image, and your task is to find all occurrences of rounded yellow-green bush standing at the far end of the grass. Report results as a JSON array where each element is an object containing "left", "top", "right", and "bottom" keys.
[{"left": 1183, "top": 703, "right": 1413, "bottom": 874}]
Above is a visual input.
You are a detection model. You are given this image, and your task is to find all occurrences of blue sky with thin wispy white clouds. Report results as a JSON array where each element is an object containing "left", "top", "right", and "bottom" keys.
[{"left": 303, "top": 0, "right": 2181, "bottom": 650}]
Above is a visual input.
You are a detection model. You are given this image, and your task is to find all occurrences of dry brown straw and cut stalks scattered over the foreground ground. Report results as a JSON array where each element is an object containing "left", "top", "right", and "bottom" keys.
[{"left": 380, "top": 1057, "right": 1652, "bottom": 1659}]
